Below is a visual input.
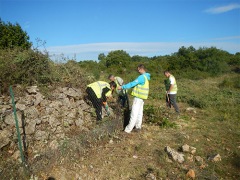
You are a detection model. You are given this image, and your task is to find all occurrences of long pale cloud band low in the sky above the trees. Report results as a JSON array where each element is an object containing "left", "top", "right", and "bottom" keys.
[{"left": 47, "top": 42, "right": 240, "bottom": 61}]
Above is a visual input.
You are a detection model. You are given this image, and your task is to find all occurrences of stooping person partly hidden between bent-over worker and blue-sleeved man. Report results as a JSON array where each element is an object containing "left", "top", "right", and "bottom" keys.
[{"left": 108, "top": 74, "right": 127, "bottom": 107}]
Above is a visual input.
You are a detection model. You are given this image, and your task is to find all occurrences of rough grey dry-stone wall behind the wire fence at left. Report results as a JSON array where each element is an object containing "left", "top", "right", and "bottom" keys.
[{"left": 0, "top": 86, "right": 95, "bottom": 159}]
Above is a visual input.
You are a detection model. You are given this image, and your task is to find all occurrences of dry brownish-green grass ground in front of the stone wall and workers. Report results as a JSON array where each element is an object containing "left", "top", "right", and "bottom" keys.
[{"left": 0, "top": 75, "right": 240, "bottom": 180}]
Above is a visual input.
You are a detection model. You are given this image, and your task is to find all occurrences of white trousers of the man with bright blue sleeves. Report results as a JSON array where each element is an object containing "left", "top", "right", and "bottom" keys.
[{"left": 124, "top": 97, "right": 144, "bottom": 133}]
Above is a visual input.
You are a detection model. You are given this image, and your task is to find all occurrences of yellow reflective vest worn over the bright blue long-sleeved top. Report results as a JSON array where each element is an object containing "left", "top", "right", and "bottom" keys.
[{"left": 132, "top": 75, "right": 149, "bottom": 99}]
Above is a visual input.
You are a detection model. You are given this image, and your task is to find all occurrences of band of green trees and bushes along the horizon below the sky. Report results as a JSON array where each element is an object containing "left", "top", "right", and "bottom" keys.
[{"left": 0, "top": 19, "right": 240, "bottom": 92}]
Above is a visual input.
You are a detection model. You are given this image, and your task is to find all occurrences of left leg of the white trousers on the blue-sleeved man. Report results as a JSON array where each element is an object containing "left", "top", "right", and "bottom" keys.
[{"left": 124, "top": 98, "right": 141, "bottom": 133}]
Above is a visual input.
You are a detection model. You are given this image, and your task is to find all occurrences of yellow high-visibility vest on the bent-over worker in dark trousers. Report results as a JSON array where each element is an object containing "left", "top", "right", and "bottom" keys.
[{"left": 87, "top": 81, "right": 111, "bottom": 98}]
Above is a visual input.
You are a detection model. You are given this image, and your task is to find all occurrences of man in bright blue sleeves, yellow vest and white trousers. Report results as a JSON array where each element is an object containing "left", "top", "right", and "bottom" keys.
[{"left": 118, "top": 64, "right": 150, "bottom": 133}]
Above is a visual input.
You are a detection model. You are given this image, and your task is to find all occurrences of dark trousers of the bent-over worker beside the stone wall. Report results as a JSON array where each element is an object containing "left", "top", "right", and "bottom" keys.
[{"left": 86, "top": 87, "right": 102, "bottom": 121}]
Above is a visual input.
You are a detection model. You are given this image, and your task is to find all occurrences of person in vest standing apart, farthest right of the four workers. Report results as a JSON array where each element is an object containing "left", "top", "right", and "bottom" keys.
[{"left": 164, "top": 71, "right": 180, "bottom": 114}]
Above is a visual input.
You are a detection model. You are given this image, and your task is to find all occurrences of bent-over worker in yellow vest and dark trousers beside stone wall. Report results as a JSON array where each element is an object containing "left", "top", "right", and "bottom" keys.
[{"left": 86, "top": 81, "right": 117, "bottom": 121}]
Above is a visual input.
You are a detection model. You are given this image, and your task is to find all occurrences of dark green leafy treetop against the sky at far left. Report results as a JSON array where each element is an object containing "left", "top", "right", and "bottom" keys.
[{"left": 0, "top": 19, "right": 32, "bottom": 49}]
